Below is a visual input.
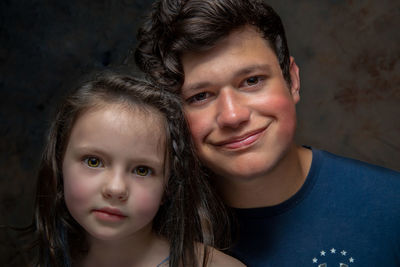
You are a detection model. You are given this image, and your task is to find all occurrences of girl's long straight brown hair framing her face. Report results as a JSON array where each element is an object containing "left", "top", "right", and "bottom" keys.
[{"left": 32, "top": 73, "right": 227, "bottom": 267}]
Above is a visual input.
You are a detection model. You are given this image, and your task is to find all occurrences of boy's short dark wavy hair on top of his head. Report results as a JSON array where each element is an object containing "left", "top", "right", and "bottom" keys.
[{"left": 134, "top": 0, "right": 291, "bottom": 92}]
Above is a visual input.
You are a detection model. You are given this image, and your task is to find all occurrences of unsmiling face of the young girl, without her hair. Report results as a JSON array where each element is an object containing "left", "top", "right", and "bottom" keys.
[{"left": 63, "top": 104, "right": 168, "bottom": 244}]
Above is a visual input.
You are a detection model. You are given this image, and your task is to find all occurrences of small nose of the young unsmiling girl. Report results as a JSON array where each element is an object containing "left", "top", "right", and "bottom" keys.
[{"left": 102, "top": 173, "right": 129, "bottom": 201}]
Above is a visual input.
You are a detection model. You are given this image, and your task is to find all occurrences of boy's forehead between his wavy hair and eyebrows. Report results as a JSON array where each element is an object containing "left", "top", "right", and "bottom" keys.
[{"left": 181, "top": 26, "right": 280, "bottom": 92}]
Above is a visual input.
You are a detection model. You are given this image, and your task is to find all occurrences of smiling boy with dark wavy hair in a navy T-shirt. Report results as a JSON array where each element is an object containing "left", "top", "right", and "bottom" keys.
[{"left": 136, "top": 0, "right": 400, "bottom": 267}]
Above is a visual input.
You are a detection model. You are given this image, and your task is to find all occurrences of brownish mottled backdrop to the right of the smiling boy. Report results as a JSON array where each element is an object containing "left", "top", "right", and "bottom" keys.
[{"left": 273, "top": 0, "right": 400, "bottom": 170}]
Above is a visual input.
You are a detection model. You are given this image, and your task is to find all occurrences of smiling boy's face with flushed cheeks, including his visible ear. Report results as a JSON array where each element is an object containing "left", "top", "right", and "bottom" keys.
[{"left": 181, "top": 27, "right": 299, "bottom": 180}]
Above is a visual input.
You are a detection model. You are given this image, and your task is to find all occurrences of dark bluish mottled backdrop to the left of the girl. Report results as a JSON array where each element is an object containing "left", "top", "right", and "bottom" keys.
[{"left": 0, "top": 0, "right": 151, "bottom": 266}]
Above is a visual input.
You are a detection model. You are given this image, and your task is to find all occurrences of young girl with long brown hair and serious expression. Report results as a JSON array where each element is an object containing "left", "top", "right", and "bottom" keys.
[{"left": 30, "top": 73, "right": 243, "bottom": 267}]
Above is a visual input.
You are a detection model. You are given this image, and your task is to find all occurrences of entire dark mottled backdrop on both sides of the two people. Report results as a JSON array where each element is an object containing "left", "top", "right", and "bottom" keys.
[{"left": 0, "top": 0, "right": 400, "bottom": 266}]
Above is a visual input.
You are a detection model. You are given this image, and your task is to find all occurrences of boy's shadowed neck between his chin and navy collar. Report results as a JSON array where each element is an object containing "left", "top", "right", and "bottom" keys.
[{"left": 218, "top": 143, "right": 312, "bottom": 208}]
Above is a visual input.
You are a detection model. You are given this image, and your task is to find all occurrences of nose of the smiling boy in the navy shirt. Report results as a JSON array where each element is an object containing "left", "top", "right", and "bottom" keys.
[{"left": 217, "top": 88, "right": 250, "bottom": 128}]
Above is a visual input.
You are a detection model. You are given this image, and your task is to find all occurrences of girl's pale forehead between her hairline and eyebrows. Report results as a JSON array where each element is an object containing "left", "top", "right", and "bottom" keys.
[{"left": 70, "top": 101, "right": 167, "bottom": 151}]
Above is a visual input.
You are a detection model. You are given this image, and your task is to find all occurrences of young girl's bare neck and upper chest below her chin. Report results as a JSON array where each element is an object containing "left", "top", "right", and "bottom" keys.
[{"left": 78, "top": 229, "right": 169, "bottom": 267}]
